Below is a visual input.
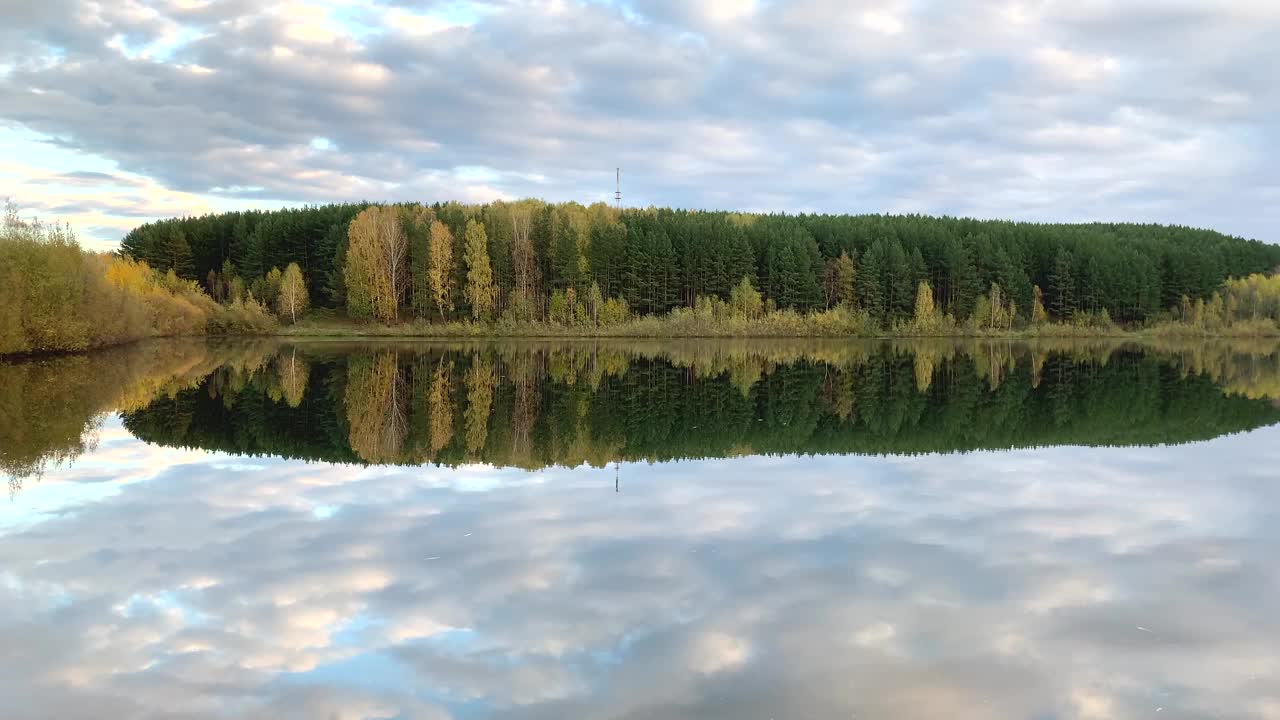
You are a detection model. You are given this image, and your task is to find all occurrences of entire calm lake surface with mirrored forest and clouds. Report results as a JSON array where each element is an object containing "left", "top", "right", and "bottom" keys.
[{"left": 0, "top": 341, "right": 1280, "bottom": 720}]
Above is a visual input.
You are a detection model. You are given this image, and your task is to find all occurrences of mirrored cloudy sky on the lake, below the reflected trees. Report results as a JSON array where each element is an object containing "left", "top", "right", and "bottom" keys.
[{"left": 0, "top": 420, "right": 1280, "bottom": 719}]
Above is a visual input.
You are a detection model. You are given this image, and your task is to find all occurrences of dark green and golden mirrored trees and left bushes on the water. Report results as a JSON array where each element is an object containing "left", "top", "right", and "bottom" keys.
[{"left": 0, "top": 341, "right": 1280, "bottom": 488}]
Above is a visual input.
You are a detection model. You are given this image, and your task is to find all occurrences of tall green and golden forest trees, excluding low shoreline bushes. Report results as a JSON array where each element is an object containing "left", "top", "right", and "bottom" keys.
[{"left": 122, "top": 200, "right": 1280, "bottom": 328}]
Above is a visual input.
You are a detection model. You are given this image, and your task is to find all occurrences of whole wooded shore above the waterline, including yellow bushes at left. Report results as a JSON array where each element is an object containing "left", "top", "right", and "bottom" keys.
[{"left": 0, "top": 200, "right": 1280, "bottom": 355}]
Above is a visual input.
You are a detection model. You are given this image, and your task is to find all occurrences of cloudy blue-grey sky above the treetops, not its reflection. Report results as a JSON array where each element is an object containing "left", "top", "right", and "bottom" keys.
[{"left": 0, "top": 0, "right": 1280, "bottom": 249}]
